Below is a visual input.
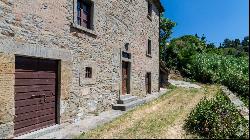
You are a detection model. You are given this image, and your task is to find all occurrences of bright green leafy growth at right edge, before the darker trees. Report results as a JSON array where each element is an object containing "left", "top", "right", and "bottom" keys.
[{"left": 188, "top": 53, "right": 249, "bottom": 98}]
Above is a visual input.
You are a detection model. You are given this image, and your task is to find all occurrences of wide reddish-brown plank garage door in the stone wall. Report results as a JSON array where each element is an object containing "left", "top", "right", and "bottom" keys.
[{"left": 14, "top": 56, "right": 57, "bottom": 135}]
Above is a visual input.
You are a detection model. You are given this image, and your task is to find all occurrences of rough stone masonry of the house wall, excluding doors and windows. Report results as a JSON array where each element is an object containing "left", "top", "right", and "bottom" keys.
[{"left": 0, "top": 0, "right": 163, "bottom": 138}]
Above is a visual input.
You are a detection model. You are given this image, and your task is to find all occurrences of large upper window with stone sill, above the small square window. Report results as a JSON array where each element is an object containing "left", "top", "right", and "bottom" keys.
[{"left": 77, "top": 0, "right": 92, "bottom": 29}]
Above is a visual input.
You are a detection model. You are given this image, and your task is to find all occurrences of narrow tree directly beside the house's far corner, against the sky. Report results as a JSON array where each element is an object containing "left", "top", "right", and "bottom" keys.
[{"left": 160, "top": 14, "right": 176, "bottom": 61}]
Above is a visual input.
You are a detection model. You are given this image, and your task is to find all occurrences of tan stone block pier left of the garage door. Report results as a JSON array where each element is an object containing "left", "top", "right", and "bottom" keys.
[{"left": 0, "top": 53, "right": 15, "bottom": 138}]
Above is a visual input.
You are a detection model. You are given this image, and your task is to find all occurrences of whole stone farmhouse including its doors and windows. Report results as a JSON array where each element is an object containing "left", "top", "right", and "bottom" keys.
[{"left": 0, "top": 0, "right": 164, "bottom": 138}]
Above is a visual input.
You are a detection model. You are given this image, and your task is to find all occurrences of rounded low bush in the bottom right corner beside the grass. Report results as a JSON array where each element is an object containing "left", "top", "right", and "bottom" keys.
[{"left": 184, "top": 93, "right": 249, "bottom": 139}]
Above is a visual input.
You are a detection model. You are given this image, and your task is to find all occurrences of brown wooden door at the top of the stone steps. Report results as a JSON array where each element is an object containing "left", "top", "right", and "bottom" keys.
[{"left": 122, "top": 62, "right": 129, "bottom": 95}]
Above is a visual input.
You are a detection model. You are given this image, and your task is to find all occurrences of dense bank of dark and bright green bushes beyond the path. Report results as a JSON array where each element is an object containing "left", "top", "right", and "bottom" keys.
[{"left": 165, "top": 35, "right": 249, "bottom": 104}]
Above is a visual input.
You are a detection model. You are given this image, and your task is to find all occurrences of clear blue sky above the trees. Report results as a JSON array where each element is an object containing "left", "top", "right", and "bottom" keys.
[{"left": 161, "top": 0, "right": 249, "bottom": 45}]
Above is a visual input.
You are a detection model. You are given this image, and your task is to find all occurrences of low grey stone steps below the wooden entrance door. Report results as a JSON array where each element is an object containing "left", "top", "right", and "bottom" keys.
[{"left": 112, "top": 99, "right": 145, "bottom": 111}]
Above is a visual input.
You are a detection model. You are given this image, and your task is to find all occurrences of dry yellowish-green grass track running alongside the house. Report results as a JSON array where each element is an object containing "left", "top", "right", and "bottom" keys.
[{"left": 78, "top": 85, "right": 219, "bottom": 139}]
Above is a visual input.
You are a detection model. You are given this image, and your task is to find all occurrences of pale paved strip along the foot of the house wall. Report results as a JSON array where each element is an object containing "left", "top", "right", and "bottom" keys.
[{"left": 14, "top": 88, "right": 169, "bottom": 139}]
